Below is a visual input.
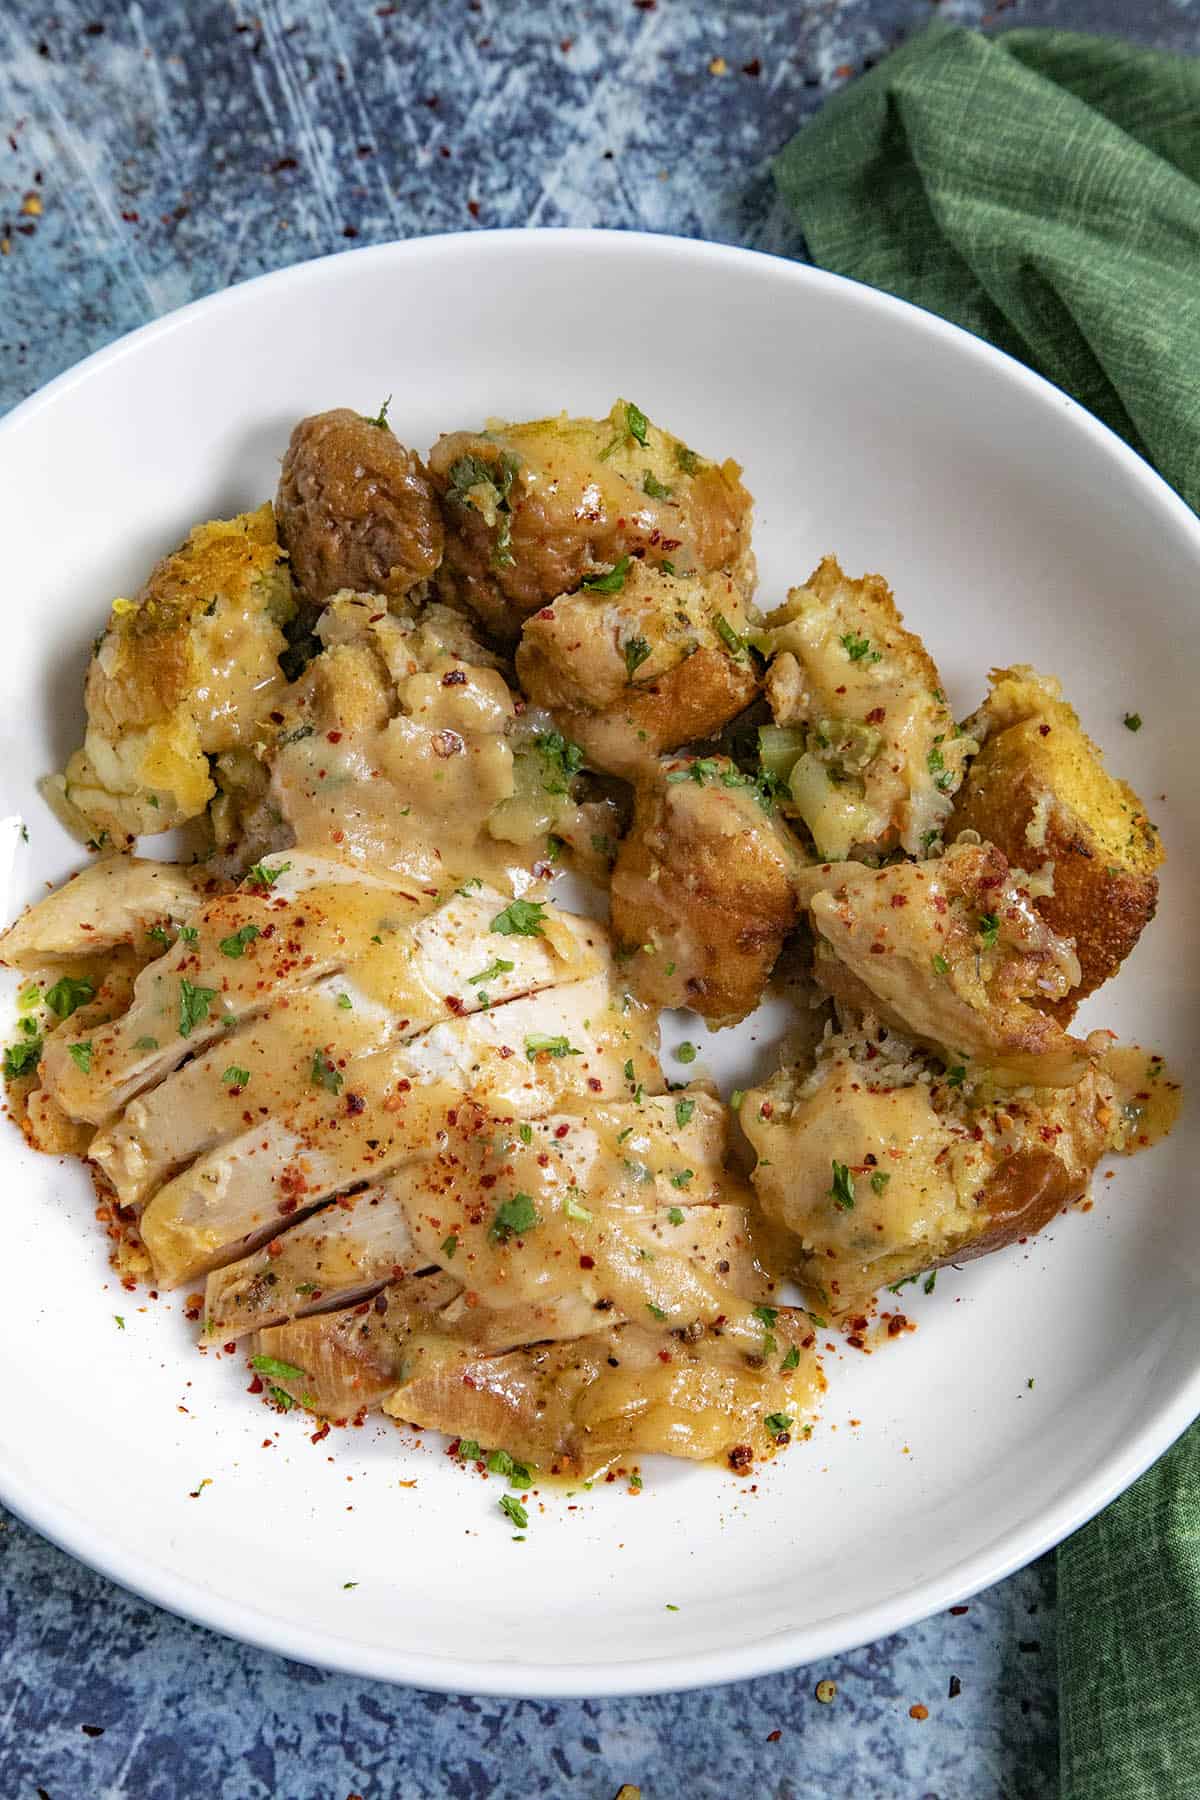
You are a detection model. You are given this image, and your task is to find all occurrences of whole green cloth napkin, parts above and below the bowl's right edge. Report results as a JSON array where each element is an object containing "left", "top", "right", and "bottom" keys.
[{"left": 775, "top": 25, "right": 1200, "bottom": 1800}]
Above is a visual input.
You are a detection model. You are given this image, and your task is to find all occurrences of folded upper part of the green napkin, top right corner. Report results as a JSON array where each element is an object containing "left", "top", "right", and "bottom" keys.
[{"left": 775, "top": 25, "right": 1200, "bottom": 514}]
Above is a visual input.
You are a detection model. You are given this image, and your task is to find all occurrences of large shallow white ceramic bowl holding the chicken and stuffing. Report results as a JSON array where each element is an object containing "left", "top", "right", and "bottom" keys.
[{"left": 0, "top": 232, "right": 1200, "bottom": 1696}]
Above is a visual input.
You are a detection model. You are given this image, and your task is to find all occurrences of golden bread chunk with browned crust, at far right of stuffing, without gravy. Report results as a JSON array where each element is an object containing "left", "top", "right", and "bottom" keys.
[{"left": 948, "top": 664, "right": 1164, "bottom": 1022}]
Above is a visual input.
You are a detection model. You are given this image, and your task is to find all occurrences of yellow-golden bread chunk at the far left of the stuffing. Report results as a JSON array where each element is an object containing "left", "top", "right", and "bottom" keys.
[{"left": 50, "top": 506, "right": 295, "bottom": 848}]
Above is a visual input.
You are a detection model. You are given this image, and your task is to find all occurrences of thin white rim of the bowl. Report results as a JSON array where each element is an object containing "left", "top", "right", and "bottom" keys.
[{"left": 0, "top": 227, "right": 1200, "bottom": 1699}]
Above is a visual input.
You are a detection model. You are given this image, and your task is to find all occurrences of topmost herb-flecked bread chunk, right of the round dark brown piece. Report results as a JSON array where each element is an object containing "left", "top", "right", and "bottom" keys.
[{"left": 428, "top": 400, "right": 754, "bottom": 641}]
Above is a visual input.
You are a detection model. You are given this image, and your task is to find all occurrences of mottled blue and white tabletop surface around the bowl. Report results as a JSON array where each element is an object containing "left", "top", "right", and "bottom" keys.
[{"left": 0, "top": 0, "right": 1200, "bottom": 1800}]
